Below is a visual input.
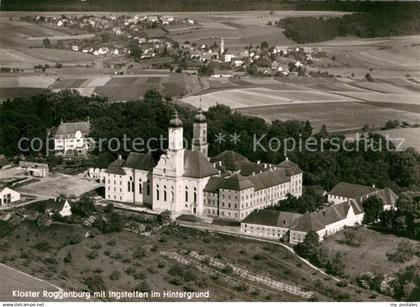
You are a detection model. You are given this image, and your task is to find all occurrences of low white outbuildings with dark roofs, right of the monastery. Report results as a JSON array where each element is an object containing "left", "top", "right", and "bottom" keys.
[{"left": 241, "top": 182, "right": 398, "bottom": 244}]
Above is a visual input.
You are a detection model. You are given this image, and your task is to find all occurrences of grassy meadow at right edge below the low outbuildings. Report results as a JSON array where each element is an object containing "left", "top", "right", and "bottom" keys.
[{"left": 322, "top": 228, "right": 420, "bottom": 279}]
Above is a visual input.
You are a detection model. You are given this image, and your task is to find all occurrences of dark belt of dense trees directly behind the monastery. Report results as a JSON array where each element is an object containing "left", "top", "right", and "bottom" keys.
[{"left": 0, "top": 90, "right": 420, "bottom": 192}]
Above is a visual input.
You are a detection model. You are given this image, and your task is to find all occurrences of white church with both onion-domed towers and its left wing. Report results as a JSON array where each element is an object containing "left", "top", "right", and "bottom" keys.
[{"left": 105, "top": 113, "right": 213, "bottom": 215}]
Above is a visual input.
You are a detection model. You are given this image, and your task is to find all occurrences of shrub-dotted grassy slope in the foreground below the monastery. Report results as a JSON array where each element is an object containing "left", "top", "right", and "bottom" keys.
[{"left": 0, "top": 219, "right": 390, "bottom": 301}]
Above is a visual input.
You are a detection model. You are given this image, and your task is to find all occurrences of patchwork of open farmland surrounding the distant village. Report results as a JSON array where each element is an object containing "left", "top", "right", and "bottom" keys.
[{"left": 0, "top": 11, "right": 420, "bottom": 135}]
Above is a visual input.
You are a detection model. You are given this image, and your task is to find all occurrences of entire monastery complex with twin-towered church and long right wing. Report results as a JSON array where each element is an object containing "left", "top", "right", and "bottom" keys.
[{"left": 105, "top": 109, "right": 302, "bottom": 221}]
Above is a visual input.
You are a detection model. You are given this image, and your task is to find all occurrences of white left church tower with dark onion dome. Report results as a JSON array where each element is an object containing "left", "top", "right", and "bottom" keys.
[{"left": 168, "top": 110, "right": 184, "bottom": 177}]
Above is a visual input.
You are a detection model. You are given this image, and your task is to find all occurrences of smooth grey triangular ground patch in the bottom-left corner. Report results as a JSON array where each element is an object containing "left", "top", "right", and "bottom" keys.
[{"left": 0, "top": 263, "right": 61, "bottom": 302}]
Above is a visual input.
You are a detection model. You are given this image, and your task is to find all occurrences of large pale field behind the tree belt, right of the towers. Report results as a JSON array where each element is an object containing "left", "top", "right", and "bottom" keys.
[{"left": 182, "top": 78, "right": 420, "bottom": 131}]
